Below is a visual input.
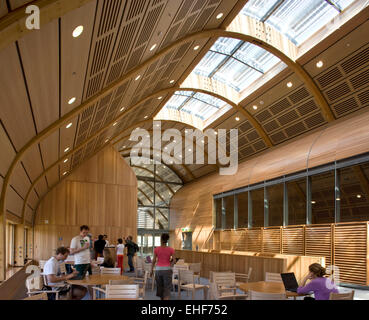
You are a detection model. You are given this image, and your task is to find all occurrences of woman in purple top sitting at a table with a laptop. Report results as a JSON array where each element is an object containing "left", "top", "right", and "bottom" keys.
[{"left": 297, "top": 263, "right": 338, "bottom": 300}]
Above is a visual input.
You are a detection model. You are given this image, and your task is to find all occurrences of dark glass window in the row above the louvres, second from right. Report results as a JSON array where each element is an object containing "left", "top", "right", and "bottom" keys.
[{"left": 311, "top": 170, "right": 335, "bottom": 224}]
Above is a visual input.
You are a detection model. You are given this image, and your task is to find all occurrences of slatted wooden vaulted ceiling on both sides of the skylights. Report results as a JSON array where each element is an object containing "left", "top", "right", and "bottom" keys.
[{"left": 0, "top": 0, "right": 369, "bottom": 228}]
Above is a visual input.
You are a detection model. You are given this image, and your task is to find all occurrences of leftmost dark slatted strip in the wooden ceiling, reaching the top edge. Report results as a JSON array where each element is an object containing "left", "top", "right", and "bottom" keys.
[{"left": 83, "top": 0, "right": 126, "bottom": 99}]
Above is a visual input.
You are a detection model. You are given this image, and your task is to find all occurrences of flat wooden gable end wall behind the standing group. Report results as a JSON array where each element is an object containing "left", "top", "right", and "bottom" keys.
[{"left": 34, "top": 146, "right": 137, "bottom": 260}]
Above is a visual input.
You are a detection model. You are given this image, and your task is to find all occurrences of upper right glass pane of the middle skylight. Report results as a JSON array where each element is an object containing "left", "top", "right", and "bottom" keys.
[{"left": 233, "top": 42, "right": 280, "bottom": 73}]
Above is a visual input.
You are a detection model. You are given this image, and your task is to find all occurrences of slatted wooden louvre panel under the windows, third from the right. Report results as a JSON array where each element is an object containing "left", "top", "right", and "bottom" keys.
[{"left": 282, "top": 226, "right": 304, "bottom": 255}]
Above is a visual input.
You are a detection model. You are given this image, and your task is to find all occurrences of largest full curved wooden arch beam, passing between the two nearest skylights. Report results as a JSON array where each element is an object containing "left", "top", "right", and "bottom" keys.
[{"left": 0, "top": 28, "right": 334, "bottom": 226}]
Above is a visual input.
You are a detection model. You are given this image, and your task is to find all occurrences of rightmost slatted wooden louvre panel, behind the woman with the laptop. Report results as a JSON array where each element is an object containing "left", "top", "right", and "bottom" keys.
[{"left": 334, "top": 223, "right": 368, "bottom": 285}]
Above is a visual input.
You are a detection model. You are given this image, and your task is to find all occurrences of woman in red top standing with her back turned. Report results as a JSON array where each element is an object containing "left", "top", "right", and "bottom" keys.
[{"left": 152, "top": 233, "right": 174, "bottom": 300}]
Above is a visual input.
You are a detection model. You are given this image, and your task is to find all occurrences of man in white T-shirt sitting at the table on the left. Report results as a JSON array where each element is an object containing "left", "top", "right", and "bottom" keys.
[{"left": 44, "top": 247, "right": 86, "bottom": 300}]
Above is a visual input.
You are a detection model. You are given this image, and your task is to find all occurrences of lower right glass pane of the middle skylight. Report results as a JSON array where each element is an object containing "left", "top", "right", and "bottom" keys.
[{"left": 214, "top": 58, "right": 262, "bottom": 91}]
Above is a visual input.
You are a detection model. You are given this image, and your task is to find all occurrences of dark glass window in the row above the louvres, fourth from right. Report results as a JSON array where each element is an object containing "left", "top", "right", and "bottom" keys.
[{"left": 267, "top": 183, "right": 284, "bottom": 227}]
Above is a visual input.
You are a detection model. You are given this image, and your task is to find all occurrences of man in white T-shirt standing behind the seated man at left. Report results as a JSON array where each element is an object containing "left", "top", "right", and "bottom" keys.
[{"left": 70, "top": 225, "right": 92, "bottom": 279}]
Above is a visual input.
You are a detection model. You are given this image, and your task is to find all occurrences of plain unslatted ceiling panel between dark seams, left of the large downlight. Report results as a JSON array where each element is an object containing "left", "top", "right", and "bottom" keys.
[{"left": 19, "top": 20, "right": 59, "bottom": 132}]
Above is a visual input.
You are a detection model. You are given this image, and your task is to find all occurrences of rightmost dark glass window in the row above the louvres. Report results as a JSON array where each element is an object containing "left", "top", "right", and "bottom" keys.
[{"left": 338, "top": 163, "right": 369, "bottom": 222}]
